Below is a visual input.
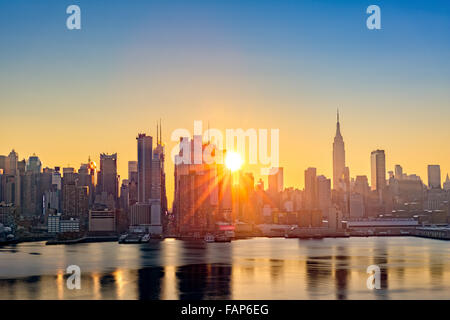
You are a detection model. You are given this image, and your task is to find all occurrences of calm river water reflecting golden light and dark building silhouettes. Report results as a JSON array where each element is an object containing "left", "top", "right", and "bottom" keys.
[{"left": 0, "top": 237, "right": 450, "bottom": 299}]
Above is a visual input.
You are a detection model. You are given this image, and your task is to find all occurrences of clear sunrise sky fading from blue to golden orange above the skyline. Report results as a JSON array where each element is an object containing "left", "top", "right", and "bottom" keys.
[{"left": 0, "top": 0, "right": 450, "bottom": 208}]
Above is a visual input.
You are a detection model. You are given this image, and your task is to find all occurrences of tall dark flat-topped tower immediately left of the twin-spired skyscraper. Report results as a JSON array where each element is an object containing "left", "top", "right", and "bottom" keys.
[{"left": 136, "top": 133, "right": 153, "bottom": 203}]
